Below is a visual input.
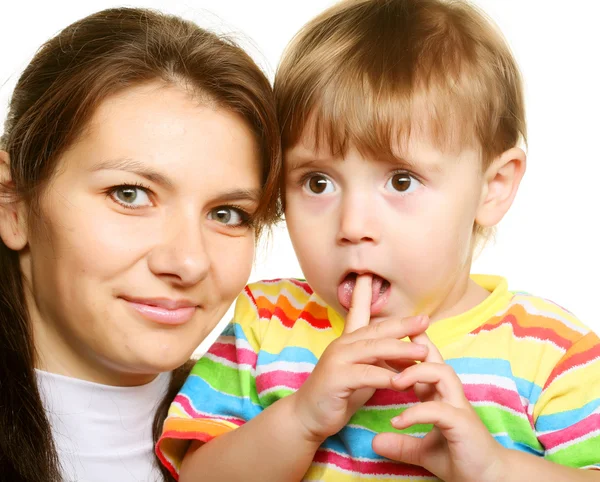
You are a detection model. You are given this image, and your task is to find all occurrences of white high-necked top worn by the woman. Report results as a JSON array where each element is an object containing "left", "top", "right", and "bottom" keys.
[{"left": 36, "top": 370, "right": 171, "bottom": 482}]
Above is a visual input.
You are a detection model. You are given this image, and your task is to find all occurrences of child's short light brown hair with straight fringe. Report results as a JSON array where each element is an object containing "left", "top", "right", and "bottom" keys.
[{"left": 274, "top": 0, "right": 526, "bottom": 167}]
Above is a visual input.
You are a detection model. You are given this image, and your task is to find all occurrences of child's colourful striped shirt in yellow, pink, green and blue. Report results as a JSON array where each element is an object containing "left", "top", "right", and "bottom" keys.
[{"left": 157, "top": 275, "right": 600, "bottom": 482}]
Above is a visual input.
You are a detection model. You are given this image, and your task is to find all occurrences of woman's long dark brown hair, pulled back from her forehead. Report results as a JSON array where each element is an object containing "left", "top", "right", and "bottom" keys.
[{"left": 0, "top": 8, "right": 280, "bottom": 481}]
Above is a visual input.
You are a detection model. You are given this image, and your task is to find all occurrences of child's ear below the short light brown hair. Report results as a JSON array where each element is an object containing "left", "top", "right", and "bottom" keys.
[{"left": 475, "top": 147, "right": 527, "bottom": 227}]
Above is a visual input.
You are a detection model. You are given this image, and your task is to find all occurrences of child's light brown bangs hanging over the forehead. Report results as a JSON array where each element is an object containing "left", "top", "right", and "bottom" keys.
[{"left": 282, "top": 62, "right": 480, "bottom": 162}]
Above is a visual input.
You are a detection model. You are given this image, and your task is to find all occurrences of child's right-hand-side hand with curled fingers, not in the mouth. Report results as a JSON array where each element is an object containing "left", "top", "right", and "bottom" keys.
[{"left": 373, "top": 334, "right": 506, "bottom": 482}]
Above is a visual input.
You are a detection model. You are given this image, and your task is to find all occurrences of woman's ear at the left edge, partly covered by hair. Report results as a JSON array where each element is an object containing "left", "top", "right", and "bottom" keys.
[{"left": 0, "top": 151, "right": 27, "bottom": 251}]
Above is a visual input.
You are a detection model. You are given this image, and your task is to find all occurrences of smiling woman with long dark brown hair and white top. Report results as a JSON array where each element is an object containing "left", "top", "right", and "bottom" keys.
[{"left": 0, "top": 8, "right": 279, "bottom": 481}]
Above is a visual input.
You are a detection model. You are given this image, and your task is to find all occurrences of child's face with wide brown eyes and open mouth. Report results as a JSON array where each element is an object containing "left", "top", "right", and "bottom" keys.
[{"left": 285, "top": 134, "right": 484, "bottom": 318}]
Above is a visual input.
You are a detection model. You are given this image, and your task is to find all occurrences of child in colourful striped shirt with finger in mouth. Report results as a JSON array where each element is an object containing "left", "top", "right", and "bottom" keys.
[{"left": 157, "top": 0, "right": 600, "bottom": 482}]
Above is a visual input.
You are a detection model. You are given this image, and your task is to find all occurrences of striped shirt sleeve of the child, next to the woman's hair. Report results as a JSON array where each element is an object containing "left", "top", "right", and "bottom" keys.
[{"left": 156, "top": 287, "right": 263, "bottom": 479}]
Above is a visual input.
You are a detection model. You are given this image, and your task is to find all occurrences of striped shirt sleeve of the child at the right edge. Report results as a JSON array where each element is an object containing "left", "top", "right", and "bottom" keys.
[{"left": 534, "top": 332, "right": 600, "bottom": 470}]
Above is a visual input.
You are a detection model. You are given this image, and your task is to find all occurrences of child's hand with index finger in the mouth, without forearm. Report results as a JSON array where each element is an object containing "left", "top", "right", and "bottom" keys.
[{"left": 291, "top": 275, "right": 427, "bottom": 443}]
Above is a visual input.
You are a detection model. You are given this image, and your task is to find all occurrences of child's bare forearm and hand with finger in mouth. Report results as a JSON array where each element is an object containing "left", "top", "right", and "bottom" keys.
[{"left": 180, "top": 277, "right": 427, "bottom": 482}]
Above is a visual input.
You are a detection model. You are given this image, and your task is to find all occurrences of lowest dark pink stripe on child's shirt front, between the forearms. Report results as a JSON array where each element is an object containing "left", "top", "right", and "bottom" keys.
[{"left": 313, "top": 449, "right": 432, "bottom": 477}]
